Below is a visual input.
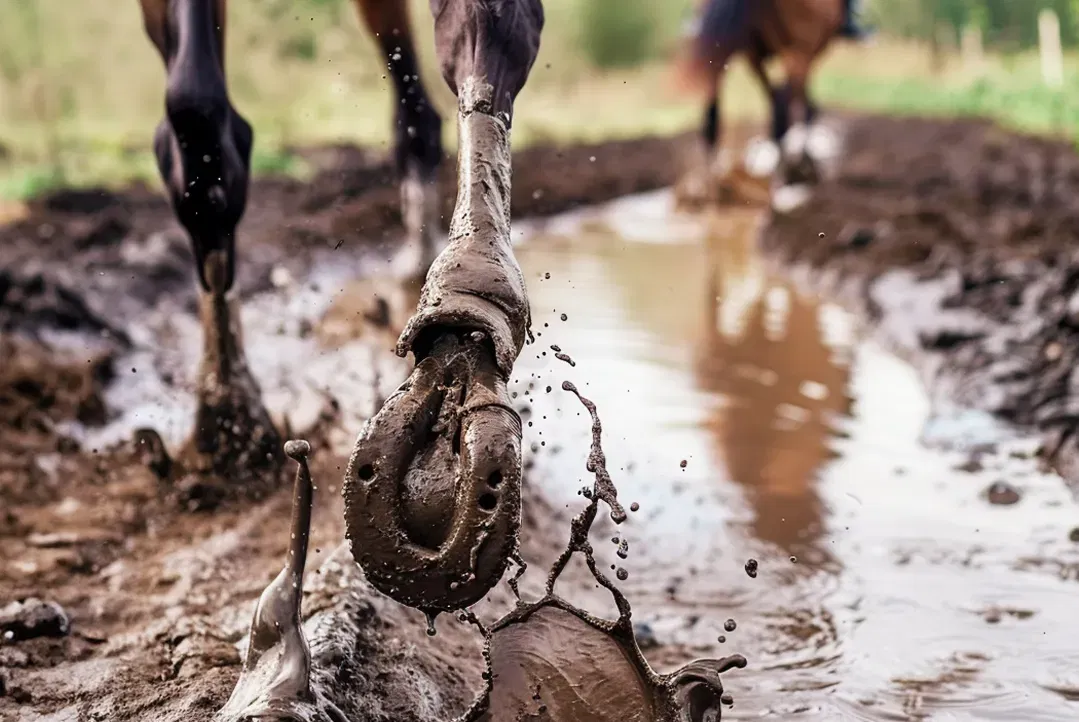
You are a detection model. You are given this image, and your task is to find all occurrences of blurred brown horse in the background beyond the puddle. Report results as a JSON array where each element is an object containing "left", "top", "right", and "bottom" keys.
[{"left": 682, "top": 0, "right": 851, "bottom": 184}]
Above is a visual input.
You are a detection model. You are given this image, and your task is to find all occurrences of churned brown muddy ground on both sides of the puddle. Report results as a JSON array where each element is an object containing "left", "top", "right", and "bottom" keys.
[{"left": 0, "top": 112, "right": 1079, "bottom": 721}]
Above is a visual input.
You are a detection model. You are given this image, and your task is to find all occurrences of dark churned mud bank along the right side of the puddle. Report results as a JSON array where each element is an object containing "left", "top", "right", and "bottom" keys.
[{"left": 762, "top": 117, "right": 1079, "bottom": 483}]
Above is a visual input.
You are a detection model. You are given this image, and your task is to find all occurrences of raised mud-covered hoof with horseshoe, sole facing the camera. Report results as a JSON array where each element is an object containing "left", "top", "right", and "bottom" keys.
[{"left": 344, "top": 332, "right": 521, "bottom": 613}]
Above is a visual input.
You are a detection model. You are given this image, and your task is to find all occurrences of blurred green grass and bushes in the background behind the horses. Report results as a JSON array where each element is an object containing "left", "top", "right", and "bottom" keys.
[{"left": 0, "top": 0, "right": 1079, "bottom": 199}]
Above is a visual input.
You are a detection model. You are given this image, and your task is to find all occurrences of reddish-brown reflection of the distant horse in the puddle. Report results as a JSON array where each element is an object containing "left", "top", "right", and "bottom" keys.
[{"left": 694, "top": 213, "right": 851, "bottom": 567}]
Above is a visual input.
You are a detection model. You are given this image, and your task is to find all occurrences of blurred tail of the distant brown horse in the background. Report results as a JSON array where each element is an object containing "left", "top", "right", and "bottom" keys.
[{"left": 679, "top": 0, "right": 755, "bottom": 92}]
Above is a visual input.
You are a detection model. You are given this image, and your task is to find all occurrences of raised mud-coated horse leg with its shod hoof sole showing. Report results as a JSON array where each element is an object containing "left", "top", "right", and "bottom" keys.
[{"left": 344, "top": 0, "right": 543, "bottom": 615}]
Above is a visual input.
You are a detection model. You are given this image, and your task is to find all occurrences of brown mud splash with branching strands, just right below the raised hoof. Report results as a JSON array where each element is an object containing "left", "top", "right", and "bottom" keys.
[{"left": 457, "top": 381, "right": 747, "bottom": 722}]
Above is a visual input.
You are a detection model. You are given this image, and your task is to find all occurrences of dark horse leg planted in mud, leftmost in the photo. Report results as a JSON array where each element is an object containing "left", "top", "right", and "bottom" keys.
[{"left": 140, "top": 0, "right": 283, "bottom": 506}]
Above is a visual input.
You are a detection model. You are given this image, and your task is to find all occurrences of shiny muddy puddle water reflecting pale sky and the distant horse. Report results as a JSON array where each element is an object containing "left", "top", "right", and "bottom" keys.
[{"left": 515, "top": 194, "right": 1079, "bottom": 720}]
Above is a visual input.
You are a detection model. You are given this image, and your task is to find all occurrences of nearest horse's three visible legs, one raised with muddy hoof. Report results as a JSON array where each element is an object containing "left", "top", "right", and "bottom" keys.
[{"left": 140, "top": 0, "right": 544, "bottom": 613}]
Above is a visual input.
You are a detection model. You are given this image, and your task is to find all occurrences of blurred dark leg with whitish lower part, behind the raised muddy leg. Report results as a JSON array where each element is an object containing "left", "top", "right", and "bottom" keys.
[{"left": 355, "top": 0, "right": 442, "bottom": 280}]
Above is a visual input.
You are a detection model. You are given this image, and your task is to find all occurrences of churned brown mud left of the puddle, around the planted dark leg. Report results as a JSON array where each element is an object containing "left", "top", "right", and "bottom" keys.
[{"left": 0, "top": 137, "right": 689, "bottom": 722}]
